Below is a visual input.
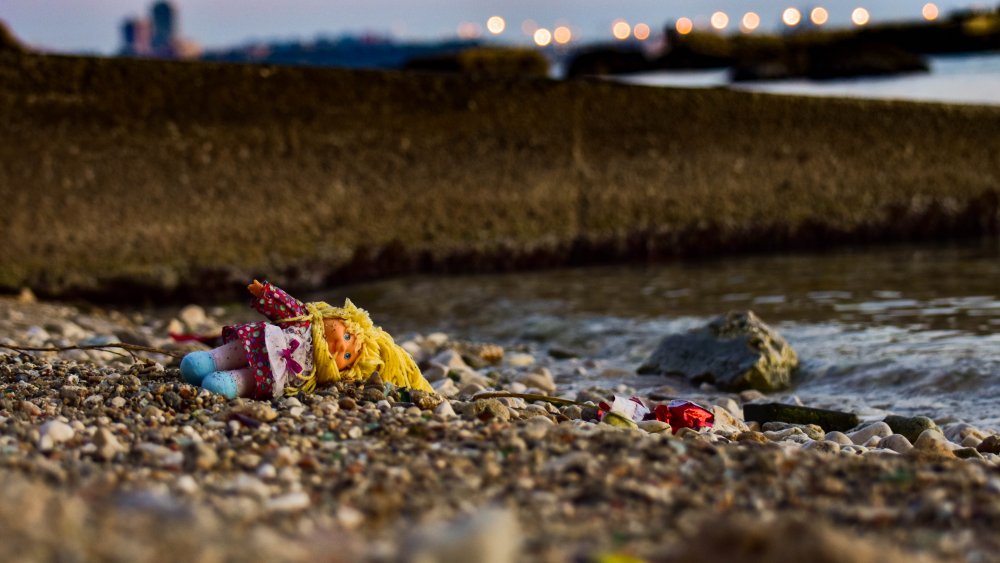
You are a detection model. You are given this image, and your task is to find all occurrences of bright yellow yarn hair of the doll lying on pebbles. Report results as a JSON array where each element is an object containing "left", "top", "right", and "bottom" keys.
[{"left": 279, "top": 299, "right": 433, "bottom": 393}]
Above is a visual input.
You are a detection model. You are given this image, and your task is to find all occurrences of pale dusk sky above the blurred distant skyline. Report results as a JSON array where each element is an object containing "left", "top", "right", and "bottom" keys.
[{"left": 0, "top": 0, "right": 997, "bottom": 54}]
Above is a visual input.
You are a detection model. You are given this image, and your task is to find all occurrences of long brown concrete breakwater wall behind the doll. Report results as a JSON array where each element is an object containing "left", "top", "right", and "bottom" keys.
[{"left": 0, "top": 53, "right": 1000, "bottom": 300}]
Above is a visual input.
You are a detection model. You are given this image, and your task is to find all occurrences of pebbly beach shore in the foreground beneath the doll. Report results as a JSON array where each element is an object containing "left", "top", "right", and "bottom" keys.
[{"left": 0, "top": 300, "right": 1000, "bottom": 563}]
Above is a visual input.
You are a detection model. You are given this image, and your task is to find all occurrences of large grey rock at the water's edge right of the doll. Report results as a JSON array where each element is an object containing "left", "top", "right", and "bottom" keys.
[{"left": 639, "top": 311, "right": 799, "bottom": 392}]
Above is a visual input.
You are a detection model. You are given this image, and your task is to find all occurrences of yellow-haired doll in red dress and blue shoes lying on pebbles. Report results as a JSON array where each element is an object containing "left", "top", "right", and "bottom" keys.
[{"left": 181, "top": 280, "right": 433, "bottom": 400}]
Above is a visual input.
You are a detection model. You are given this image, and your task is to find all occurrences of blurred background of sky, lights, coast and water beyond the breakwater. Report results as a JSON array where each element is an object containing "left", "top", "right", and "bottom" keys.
[{"left": 0, "top": 0, "right": 1000, "bottom": 104}]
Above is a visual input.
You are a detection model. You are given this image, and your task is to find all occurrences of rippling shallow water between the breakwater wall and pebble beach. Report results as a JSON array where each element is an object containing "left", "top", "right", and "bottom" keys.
[{"left": 332, "top": 242, "right": 1000, "bottom": 430}]
